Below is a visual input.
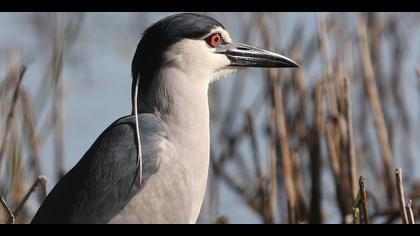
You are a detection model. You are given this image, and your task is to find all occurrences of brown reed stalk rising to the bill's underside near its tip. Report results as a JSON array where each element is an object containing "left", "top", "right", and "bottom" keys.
[{"left": 268, "top": 69, "right": 296, "bottom": 224}]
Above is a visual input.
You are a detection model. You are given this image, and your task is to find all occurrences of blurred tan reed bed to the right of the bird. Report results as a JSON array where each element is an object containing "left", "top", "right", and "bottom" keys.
[{"left": 203, "top": 13, "right": 419, "bottom": 223}]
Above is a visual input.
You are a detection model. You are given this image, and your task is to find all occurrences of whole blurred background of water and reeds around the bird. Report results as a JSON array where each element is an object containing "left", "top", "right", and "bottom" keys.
[{"left": 0, "top": 12, "right": 420, "bottom": 223}]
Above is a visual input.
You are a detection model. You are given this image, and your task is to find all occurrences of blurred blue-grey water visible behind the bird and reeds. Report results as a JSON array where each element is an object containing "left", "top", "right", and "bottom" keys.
[{"left": 0, "top": 12, "right": 419, "bottom": 223}]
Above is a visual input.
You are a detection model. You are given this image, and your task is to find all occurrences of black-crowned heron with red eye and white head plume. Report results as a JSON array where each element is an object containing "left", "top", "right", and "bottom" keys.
[{"left": 31, "top": 13, "right": 299, "bottom": 224}]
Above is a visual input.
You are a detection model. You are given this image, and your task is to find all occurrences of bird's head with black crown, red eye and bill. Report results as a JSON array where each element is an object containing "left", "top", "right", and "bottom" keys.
[{"left": 132, "top": 13, "right": 298, "bottom": 92}]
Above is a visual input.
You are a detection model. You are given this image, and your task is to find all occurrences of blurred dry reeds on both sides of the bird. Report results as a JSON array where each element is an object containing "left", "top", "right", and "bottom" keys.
[{"left": 0, "top": 13, "right": 420, "bottom": 224}]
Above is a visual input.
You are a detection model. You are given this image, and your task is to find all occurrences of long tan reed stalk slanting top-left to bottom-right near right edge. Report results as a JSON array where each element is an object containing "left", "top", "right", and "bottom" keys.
[{"left": 358, "top": 16, "right": 395, "bottom": 208}]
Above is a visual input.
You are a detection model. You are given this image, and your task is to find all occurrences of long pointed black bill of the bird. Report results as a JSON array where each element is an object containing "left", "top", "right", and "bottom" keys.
[{"left": 216, "top": 43, "right": 299, "bottom": 68}]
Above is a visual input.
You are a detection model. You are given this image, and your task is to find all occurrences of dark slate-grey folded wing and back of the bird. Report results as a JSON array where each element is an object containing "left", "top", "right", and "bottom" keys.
[{"left": 32, "top": 114, "right": 167, "bottom": 223}]
